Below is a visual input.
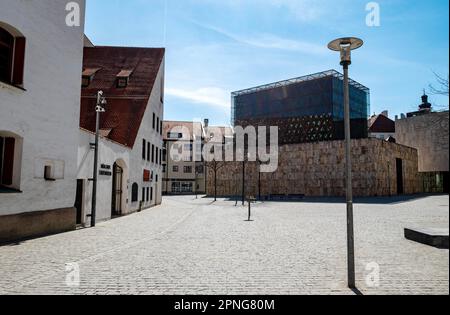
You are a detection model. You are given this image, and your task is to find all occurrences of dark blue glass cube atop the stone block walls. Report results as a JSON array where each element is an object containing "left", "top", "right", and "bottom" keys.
[{"left": 231, "top": 70, "right": 370, "bottom": 143}]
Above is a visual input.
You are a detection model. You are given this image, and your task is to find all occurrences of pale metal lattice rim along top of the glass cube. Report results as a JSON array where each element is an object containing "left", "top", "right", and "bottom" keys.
[{"left": 231, "top": 70, "right": 370, "bottom": 97}]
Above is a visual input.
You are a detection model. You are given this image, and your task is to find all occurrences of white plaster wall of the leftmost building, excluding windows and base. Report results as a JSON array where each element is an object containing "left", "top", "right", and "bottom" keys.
[{"left": 0, "top": 0, "right": 85, "bottom": 215}]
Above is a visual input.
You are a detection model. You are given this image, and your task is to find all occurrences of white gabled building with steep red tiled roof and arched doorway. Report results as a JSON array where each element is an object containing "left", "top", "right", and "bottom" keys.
[{"left": 74, "top": 47, "right": 165, "bottom": 224}]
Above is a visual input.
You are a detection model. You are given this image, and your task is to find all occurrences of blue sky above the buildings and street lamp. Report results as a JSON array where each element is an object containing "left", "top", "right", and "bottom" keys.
[{"left": 86, "top": 0, "right": 449, "bottom": 125}]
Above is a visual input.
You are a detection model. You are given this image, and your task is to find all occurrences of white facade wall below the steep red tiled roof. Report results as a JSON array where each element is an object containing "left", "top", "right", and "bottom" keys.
[{"left": 77, "top": 56, "right": 164, "bottom": 223}]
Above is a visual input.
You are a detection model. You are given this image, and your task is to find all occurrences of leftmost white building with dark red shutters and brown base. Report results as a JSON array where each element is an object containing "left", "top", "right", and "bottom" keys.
[{"left": 0, "top": 0, "right": 85, "bottom": 242}]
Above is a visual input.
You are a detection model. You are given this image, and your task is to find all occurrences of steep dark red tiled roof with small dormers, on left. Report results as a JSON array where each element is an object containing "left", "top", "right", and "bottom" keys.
[{"left": 80, "top": 46, "right": 165, "bottom": 148}]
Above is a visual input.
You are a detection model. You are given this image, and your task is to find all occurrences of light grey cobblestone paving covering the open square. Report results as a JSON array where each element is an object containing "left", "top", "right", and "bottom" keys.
[{"left": 0, "top": 195, "right": 449, "bottom": 295}]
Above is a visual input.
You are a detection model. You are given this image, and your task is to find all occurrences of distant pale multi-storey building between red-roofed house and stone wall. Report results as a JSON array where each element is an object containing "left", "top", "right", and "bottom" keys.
[{"left": 163, "top": 121, "right": 206, "bottom": 195}]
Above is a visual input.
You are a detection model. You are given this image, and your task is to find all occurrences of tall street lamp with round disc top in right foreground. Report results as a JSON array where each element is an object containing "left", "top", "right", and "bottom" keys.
[{"left": 328, "top": 37, "right": 364, "bottom": 289}]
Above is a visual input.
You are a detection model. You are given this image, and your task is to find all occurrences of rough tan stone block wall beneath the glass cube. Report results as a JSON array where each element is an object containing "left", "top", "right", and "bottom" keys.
[{"left": 207, "top": 139, "right": 420, "bottom": 197}]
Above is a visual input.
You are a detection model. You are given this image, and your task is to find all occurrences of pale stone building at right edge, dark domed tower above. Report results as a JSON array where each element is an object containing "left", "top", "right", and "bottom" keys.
[{"left": 395, "top": 95, "right": 449, "bottom": 193}]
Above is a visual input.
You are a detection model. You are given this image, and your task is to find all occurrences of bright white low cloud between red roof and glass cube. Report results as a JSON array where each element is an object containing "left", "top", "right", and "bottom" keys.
[{"left": 165, "top": 87, "right": 231, "bottom": 109}]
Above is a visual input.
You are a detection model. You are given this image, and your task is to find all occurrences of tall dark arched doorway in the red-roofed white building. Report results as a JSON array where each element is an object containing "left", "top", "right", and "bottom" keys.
[{"left": 111, "top": 160, "right": 127, "bottom": 218}]
